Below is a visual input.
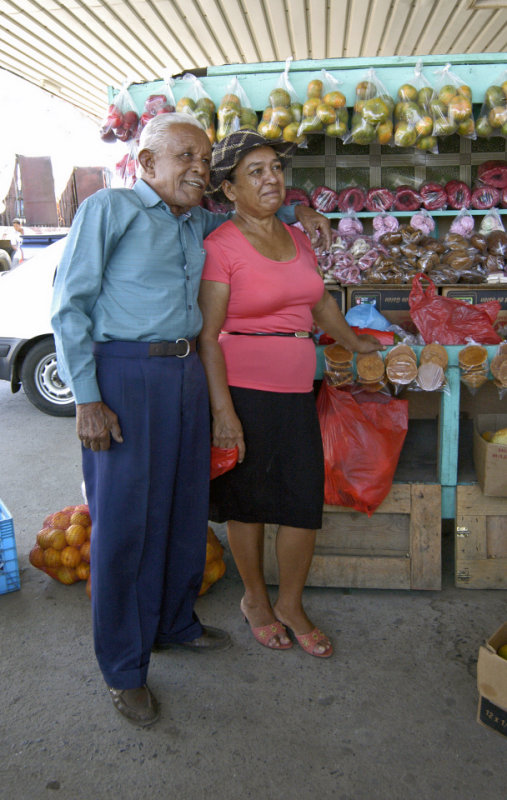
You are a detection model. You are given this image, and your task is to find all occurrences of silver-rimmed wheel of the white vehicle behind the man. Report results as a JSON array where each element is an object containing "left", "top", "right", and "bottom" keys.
[{"left": 21, "top": 337, "right": 76, "bottom": 417}]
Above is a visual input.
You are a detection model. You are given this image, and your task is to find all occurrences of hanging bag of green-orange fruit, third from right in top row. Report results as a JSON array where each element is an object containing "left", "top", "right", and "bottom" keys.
[{"left": 394, "top": 61, "right": 438, "bottom": 153}]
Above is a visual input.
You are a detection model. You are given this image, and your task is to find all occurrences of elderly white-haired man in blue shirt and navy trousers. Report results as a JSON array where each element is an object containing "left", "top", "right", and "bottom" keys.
[{"left": 52, "top": 113, "right": 329, "bottom": 725}]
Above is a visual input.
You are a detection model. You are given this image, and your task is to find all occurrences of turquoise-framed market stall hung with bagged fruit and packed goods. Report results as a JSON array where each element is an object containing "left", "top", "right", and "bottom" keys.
[{"left": 103, "top": 53, "right": 507, "bottom": 589}]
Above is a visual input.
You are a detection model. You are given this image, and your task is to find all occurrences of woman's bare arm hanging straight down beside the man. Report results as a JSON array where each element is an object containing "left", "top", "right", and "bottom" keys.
[{"left": 199, "top": 280, "right": 245, "bottom": 463}]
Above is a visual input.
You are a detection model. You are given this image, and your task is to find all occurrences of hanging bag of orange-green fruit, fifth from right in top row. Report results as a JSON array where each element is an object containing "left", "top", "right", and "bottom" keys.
[{"left": 298, "top": 69, "right": 349, "bottom": 139}]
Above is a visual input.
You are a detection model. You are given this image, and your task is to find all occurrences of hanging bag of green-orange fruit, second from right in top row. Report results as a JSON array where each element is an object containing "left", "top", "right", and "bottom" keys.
[{"left": 431, "top": 64, "right": 477, "bottom": 139}]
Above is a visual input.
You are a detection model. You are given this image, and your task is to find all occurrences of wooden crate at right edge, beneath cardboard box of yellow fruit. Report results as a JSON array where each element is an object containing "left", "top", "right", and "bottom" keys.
[{"left": 455, "top": 484, "right": 507, "bottom": 589}]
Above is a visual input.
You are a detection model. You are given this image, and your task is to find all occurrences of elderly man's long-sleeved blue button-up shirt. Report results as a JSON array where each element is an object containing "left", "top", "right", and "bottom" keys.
[{"left": 51, "top": 180, "right": 295, "bottom": 403}]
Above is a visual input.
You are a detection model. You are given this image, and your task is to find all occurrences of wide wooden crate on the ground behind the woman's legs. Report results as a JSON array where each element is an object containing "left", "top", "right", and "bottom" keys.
[{"left": 264, "top": 483, "right": 442, "bottom": 589}]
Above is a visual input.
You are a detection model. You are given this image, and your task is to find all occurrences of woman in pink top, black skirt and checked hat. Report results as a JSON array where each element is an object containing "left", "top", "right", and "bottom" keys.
[{"left": 199, "top": 131, "right": 380, "bottom": 658}]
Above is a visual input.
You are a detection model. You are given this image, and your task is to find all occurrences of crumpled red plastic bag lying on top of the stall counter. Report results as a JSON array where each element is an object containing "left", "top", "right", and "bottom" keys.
[{"left": 408, "top": 272, "right": 502, "bottom": 344}]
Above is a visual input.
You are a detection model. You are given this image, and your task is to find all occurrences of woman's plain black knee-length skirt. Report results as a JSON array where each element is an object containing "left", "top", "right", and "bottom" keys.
[{"left": 209, "top": 386, "right": 324, "bottom": 529}]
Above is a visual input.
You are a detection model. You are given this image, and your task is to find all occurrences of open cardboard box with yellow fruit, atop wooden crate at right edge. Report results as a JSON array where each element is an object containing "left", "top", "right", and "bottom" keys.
[{"left": 474, "top": 414, "right": 507, "bottom": 497}]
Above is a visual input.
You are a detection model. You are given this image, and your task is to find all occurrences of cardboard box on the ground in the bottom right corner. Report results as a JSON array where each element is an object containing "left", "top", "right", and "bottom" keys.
[{"left": 477, "top": 622, "right": 507, "bottom": 736}]
